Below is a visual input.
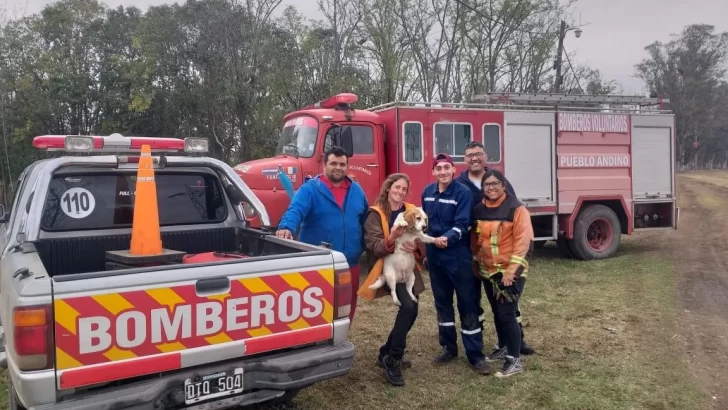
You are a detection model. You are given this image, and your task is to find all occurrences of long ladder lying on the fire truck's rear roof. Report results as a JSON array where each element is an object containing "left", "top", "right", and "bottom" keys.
[{"left": 473, "top": 92, "right": 670, "bottom": 108}]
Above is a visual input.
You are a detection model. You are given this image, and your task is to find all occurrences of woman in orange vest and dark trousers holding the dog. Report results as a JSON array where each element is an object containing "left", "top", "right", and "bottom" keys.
[{"left": 357, "top": 174, "right": 425, "bottom": 386}]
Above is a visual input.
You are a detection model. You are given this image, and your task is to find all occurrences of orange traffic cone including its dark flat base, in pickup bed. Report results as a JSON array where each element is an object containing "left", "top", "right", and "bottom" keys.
[{"left": 106, "top": 145, "right": 186, "bottom": 270}]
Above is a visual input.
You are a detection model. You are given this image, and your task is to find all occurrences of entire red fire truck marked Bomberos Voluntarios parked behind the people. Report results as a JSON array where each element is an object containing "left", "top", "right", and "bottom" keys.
[{"left": 235, "top": 93, "right": 679, "bottom": 260}]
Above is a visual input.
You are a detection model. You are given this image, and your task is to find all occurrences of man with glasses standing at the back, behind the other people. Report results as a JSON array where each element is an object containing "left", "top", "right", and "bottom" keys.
[{"left": 456, "top": 141, "right": 535, "bottom": 356}]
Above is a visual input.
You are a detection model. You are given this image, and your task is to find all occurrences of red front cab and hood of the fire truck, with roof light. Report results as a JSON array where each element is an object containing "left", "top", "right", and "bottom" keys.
[{"left": 234, "top": 93, "right": 386, "bottom": 227}]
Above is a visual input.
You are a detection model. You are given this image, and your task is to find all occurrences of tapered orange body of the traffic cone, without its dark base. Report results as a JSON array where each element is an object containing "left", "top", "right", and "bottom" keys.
[{"left": 129, "top": 145, "right": 162, "bottom": 256}]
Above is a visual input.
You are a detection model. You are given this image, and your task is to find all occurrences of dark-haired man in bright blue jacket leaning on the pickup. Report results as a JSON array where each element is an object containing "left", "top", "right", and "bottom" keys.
[{"left": 276, "top": 147, "right": 369, "bottom": 320}]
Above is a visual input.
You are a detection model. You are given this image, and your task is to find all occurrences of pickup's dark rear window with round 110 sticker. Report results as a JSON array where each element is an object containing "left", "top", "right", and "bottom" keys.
[{"left": 41, "top": 172, "right": 227, "bottom": 231}]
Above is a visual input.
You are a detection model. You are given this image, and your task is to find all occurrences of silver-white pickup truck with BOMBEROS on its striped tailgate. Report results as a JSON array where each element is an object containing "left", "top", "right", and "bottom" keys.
[{"left": 0, "top": 134, "right": 354, "bottom": 410}]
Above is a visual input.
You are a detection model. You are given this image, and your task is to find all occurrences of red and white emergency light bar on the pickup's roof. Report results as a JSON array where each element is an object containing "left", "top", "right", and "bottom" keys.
[{"left": 33, "top": 134, "right": 202, "bottom": 153}]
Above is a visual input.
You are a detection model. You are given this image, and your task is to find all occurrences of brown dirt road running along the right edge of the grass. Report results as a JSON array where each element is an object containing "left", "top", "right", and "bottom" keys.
[{"left": 660, "top": 172, "right": 728, "bottom": 409}]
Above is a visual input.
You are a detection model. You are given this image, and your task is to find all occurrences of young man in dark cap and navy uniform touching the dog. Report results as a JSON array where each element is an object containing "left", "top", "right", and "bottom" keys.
[{"left": 421, "top": 154, "right": 490, "bottom": 374}]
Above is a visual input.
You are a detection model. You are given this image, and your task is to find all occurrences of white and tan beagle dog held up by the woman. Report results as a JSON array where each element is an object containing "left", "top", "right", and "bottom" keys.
[{"left": 369, "top": 207, "right": 435, "bottom": 306}]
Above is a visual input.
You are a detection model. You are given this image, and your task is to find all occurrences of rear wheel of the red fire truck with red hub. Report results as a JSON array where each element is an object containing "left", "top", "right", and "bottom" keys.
[{"left": 569, "top": 204, "right": 622, "bottom": 260}]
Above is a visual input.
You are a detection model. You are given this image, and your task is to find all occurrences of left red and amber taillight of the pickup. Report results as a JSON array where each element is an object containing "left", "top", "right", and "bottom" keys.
[{"left": 13, "top": 305, "right": 53, "bottom": 371}]
